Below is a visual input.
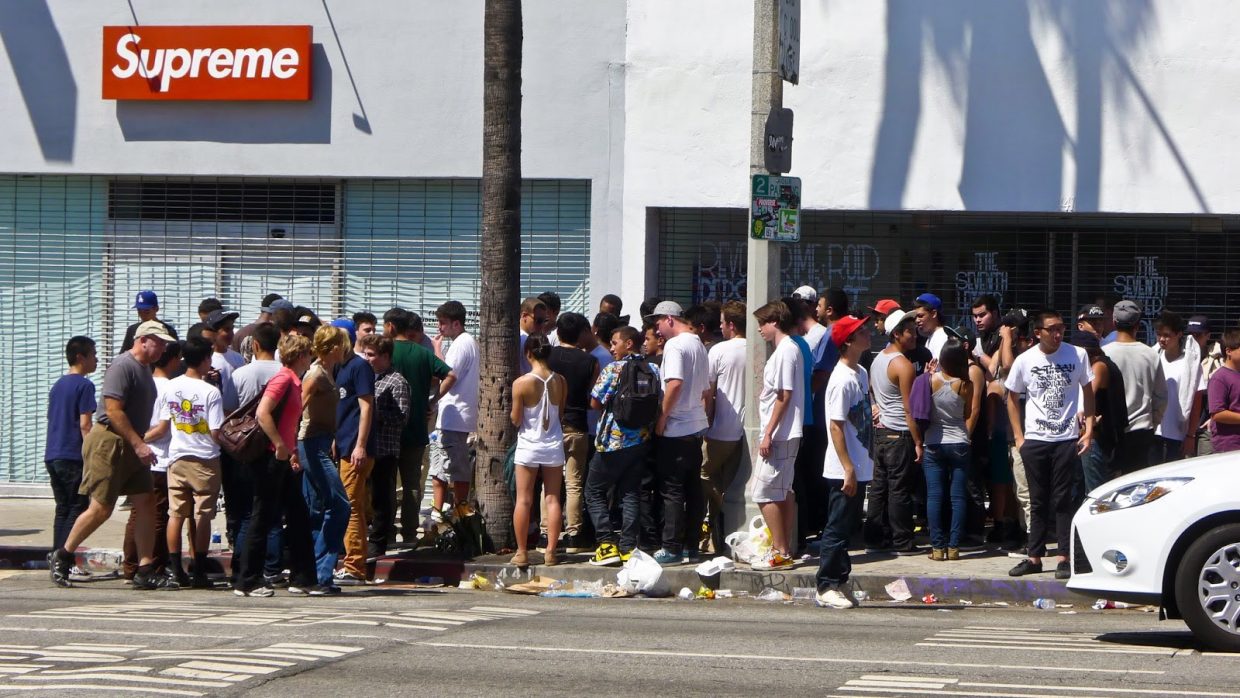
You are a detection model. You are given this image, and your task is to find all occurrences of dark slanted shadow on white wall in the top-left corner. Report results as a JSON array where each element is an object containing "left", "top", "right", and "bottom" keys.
[{"left": 0, "top": 0, "right": 78, "bottom": 162}]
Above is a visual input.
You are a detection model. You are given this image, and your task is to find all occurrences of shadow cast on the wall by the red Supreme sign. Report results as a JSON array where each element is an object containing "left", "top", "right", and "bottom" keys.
[{"left": 117, "top": 43, "right": 332, "bottom": 144}]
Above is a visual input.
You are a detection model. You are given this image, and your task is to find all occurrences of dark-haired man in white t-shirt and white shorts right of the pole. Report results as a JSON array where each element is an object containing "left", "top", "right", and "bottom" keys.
[{"left": 751, "top": 301, "right": 806, "bottom": 570}]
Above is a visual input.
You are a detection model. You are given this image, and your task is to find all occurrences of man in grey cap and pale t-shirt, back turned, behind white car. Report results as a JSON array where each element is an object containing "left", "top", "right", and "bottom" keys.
[{"left": 1102, "top": 300, "right": 1167, "bottom": 475}]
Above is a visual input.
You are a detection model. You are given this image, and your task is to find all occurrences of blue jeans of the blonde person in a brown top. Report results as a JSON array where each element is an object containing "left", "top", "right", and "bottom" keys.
[{"left": 298, "top": 436, "right": 350, "bottom": 584}]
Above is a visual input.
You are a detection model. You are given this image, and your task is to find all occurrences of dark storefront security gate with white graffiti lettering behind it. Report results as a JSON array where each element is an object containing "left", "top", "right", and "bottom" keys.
[{"left": 658, "top": 208, "right": 1240, "bottom": 343}]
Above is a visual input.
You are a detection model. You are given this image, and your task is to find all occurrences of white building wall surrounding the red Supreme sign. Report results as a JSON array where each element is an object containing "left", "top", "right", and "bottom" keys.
[{"left": 0, "top": 0, "right": 625, "bottom": 303}]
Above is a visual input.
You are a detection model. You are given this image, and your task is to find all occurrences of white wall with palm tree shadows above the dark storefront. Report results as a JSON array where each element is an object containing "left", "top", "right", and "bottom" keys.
[{"left": 624, "top": 0, "right": 1240, "bottom": 304}]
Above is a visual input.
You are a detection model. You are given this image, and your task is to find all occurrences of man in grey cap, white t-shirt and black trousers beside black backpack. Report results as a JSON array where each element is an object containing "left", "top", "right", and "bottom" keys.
[{"left": 645, "top": 300, "right": 711, "bottom": 564}]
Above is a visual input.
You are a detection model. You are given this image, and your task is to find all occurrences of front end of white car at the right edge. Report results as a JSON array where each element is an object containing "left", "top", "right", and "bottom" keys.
[{"left": 1068, "top": 453, "right": 1240, "bottom": 652}]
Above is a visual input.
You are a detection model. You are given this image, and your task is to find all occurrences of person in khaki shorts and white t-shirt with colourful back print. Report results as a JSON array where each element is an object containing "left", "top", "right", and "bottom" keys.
[{"left": 148, "top": 338, "right": 224, "bottom": 589}]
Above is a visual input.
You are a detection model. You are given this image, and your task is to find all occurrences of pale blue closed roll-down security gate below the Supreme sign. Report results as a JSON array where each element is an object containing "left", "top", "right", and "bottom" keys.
[{"left": 0, "top": 175, "right": 590, "bottom": 484}]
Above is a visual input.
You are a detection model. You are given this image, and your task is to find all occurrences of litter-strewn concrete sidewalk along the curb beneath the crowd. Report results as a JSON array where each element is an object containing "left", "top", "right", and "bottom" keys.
[{"left": 0, "top": 498, "right": 1084, "bottom": 605}]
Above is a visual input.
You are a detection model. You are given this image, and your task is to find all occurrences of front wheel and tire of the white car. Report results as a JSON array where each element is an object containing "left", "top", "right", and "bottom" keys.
[{"left": 1176, "top": 523, "right": 1240, "bottom": 652}]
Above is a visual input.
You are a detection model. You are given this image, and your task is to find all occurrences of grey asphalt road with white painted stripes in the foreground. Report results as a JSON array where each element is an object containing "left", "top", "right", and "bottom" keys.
[{"left": 0, "top": 572, "right": 1240, "bottom": 698}]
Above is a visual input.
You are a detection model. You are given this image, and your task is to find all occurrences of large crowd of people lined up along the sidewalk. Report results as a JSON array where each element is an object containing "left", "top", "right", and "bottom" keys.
[{"left": 36, "top": 286, "right": 1240, "bottom": 607}]
